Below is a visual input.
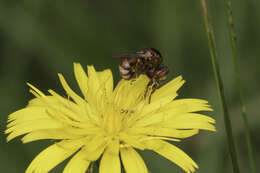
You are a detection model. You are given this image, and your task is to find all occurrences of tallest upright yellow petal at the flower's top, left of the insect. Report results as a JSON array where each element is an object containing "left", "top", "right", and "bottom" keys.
[{"left": 74, "top": 63, "right": 88, "bottom": 98}]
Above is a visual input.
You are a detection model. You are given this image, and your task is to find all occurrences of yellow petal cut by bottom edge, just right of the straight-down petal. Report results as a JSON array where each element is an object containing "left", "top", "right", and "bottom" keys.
[{"left": 120, "top": 148, "right": 148, "bottom": 173}]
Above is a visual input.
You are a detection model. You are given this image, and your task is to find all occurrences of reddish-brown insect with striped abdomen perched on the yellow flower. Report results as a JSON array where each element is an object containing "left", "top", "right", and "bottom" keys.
[{"left": 113, "top": 48, "right": 169, "bottom": 103}]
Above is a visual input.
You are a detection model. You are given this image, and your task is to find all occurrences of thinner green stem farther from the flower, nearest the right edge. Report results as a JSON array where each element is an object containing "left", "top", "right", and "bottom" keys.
[{"left": 225, "top": 0, "right": 256, "bottom": 173}]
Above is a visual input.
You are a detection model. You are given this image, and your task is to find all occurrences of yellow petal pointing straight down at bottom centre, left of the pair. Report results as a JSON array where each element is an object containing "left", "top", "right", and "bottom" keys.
[{"left": 99, "top": 140, "right": 121, "bottom": 173}]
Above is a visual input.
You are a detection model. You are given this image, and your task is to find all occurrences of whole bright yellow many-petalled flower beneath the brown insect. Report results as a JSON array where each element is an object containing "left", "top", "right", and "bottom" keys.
[{"left": 5, "top": 63, "right": 215, "bottom": 173}]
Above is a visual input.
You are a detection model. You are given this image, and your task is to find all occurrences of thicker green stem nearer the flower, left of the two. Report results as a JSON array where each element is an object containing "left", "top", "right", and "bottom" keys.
[{"left": 201, "top": 0, "right": 240, "bottom": 173}]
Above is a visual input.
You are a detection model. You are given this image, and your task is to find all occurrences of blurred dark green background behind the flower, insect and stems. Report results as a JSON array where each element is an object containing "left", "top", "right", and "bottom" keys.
[{"left": 0, "top": 0, "right": 260, "bottom": 173}]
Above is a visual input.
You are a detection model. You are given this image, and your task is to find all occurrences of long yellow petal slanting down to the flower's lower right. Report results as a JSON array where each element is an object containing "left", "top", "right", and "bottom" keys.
[{"left": 146, "top": 140, "right": 198, "bottom": 173}]
